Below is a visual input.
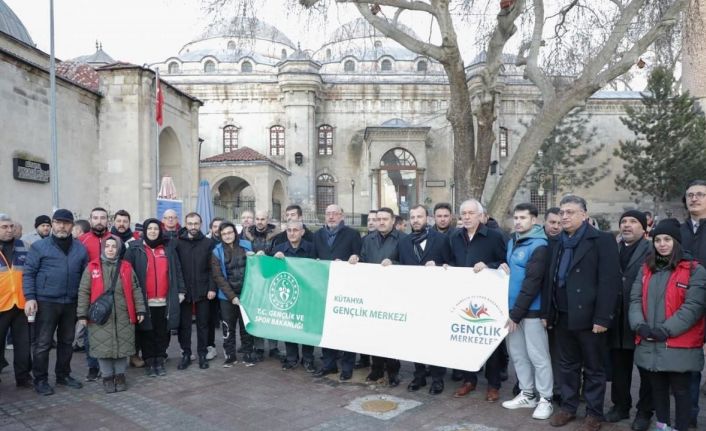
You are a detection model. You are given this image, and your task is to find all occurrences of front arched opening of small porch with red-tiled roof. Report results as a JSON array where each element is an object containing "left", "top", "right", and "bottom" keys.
[{"left": 211, "top": 174, "right": 256, "bottom": 222}]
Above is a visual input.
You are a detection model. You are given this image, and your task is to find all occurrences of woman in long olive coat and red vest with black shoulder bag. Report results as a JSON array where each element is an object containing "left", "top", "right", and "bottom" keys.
[{"left": 77, "top": 236, "right": 145, "bottom": 393}]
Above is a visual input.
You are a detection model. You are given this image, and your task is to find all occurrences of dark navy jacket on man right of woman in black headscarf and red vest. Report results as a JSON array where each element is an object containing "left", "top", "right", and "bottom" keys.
[{"left": 176, "top": 228, "right": 216, "bottom": 302}]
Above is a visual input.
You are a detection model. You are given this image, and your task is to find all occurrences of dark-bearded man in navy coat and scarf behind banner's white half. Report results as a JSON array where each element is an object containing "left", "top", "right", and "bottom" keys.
[{"left": 398, "top": 205, "right": 453, "bottom": 395}]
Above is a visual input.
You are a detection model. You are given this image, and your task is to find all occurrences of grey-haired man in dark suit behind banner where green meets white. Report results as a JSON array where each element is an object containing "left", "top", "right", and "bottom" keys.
[{"left": 314, "top": 204, "right": 362, "bottom": 381}]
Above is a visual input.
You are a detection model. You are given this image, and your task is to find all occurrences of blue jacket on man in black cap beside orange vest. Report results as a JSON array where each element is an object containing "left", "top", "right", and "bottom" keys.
[{"left": 22, "top": 235, "right": 88, "bottom": 304}]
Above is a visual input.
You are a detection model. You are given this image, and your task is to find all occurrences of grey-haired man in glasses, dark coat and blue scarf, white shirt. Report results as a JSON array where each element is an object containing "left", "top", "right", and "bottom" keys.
[{"left": 542, "top": 195, "right": 622, "bottom": 431}]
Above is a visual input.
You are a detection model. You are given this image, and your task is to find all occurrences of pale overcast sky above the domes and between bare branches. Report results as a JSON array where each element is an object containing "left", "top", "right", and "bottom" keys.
[{"left": 5, "top": 0, "right": 452, "bottom": 64}]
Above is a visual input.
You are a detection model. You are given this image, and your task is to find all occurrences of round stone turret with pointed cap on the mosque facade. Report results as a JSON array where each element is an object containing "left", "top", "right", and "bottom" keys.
[{"left": 277, "top": 48, "right": 322, "bottom": 212}]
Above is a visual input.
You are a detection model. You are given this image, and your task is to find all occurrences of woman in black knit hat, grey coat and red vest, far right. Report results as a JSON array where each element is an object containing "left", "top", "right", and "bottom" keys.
[{"left": 630, "top": 219, "right": 706, "bottom": 431}]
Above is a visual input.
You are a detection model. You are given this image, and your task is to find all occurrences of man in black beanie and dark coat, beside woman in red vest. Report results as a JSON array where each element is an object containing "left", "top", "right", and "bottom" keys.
[{"left": 606, "top": 210, "right": 654, "bottom": 431}]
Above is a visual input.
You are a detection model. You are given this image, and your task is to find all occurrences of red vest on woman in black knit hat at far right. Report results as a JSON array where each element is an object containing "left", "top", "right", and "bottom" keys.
[{"left": 635, "top": 260, "right": 706, "bottom": 349}]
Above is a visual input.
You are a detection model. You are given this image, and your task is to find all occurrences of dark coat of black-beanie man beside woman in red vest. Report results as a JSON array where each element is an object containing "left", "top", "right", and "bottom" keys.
[{"left": 608, "top": 239, "right": 652, "bottom": 350}]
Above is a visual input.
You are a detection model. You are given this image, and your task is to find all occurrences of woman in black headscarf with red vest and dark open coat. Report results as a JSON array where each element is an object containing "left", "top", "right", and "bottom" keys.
[{"left": 125, "top": 218, "right": 186, "bottom": 377}]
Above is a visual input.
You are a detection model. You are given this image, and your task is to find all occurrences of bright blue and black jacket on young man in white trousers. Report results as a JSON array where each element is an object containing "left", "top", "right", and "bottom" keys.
[{"left": 507, "top": 224, "right": 549, "bottom": 323}]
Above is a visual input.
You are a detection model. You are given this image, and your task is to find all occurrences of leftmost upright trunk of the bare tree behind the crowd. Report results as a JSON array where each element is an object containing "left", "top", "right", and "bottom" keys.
[{"left": 443, "top": 58, "right": 472, "bottom": 211}]
